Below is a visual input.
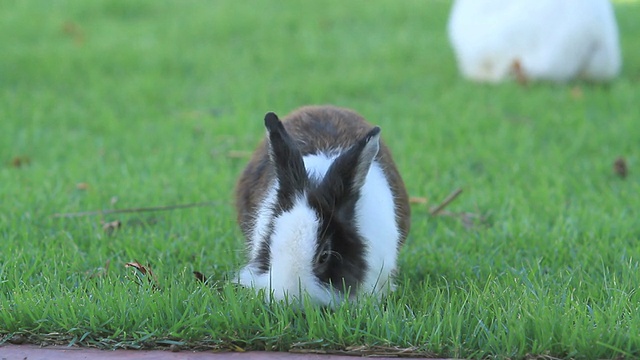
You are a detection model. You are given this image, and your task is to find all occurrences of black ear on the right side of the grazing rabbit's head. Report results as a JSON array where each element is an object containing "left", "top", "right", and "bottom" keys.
[{"left": 321, "top": 126, "right": 380, "bottom": 207}]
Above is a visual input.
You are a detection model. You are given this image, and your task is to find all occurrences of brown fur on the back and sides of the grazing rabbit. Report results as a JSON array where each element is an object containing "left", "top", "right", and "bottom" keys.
[{"left": 236, "top": 106, "right": 411, "bottom": 242}]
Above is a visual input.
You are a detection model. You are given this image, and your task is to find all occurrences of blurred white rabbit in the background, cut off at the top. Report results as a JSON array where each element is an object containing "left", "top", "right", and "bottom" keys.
[{"left": 448, "top": 0, "right": 622, "bottom": 83}]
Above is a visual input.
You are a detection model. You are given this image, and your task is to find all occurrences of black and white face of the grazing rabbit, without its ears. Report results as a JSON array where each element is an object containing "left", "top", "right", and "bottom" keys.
[{"left": 241, "top": 196, "right": 366, "bottom": 305}]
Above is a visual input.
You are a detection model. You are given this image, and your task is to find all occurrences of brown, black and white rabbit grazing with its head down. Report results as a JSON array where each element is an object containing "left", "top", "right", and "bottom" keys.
[{"left": 236, "top": 106, "right": 410, "bottom": 307}]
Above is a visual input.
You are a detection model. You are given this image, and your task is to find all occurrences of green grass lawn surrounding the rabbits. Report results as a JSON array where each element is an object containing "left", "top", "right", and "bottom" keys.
[{"left": 0, "top": 0, "right": 640, "bottom": 358}]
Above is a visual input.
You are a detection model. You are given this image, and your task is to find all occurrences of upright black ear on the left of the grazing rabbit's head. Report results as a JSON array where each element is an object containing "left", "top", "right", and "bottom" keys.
[{"left": 264, "top": 112, "right": 307, "bottom": 211}]
